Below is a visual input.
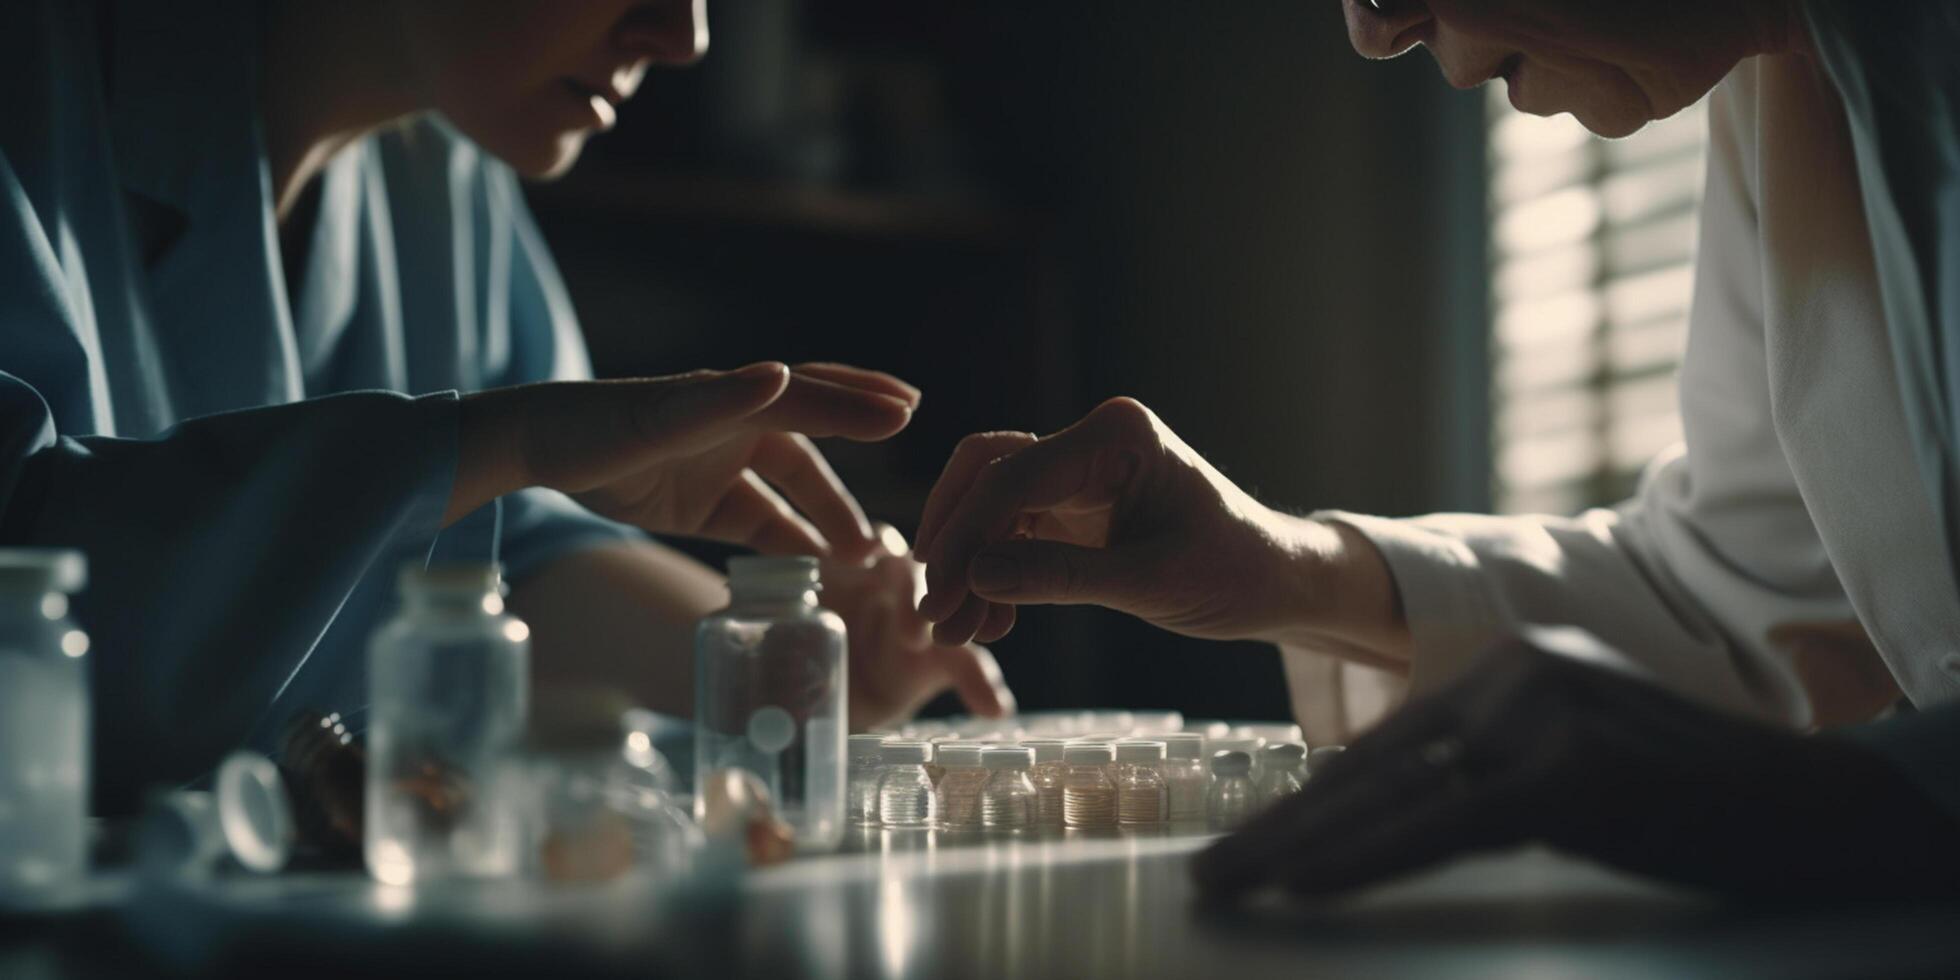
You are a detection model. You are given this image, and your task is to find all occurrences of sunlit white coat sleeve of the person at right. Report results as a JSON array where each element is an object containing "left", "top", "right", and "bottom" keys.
[{"left": 1284, "top": 63, "right": 1854, "bottom": 727}]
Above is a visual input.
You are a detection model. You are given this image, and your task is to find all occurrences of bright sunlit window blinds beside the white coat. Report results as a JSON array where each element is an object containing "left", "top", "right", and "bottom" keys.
[{"left": 1490, "top": 86, "right": 1707, "bottom": 514}]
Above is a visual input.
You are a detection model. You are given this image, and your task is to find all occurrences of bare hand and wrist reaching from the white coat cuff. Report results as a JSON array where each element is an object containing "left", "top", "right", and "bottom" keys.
[{"left": 917, "top": 398, "right": 1405, "bottom": 661}]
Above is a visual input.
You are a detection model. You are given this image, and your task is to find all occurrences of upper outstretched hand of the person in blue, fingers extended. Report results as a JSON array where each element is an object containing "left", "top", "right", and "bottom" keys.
[{"left": 449, "top": 363, "right": 919, "bottom": 561}]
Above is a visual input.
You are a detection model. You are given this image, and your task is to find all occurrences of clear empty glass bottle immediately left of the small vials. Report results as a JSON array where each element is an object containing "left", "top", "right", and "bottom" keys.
[{"left": 694, "top": 557, "right": 847, "bottom": 851}]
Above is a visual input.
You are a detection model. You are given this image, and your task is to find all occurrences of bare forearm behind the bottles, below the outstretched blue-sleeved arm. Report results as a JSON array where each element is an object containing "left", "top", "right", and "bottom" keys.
[{"left": 510, "top": 541, "right": 727, "bottom": 715}]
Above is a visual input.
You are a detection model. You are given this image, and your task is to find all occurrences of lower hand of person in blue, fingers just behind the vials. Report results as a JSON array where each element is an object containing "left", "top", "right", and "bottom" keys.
[{"left": 823, "top": 525, "right": 1015, "bottom": 731}]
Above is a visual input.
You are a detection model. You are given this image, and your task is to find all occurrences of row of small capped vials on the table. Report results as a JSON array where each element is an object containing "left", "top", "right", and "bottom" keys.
[{"left": 847, "top": 731, "right": 1341, "bottom": 831}]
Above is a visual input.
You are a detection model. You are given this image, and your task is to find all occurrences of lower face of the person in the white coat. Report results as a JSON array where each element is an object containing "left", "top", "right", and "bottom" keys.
[{"left": 1341, "top": 0, "right": 1788, "bottom": 137}]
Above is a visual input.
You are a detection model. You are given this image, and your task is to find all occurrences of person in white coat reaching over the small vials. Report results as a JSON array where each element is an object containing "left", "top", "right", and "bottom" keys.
[{"left": 919, "top": 0, "right": 1960, "bottom": 896}]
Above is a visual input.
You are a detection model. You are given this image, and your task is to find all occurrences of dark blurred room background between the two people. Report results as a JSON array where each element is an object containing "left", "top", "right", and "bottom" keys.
[{"left": 533, "top": 0, "right": 1490, "bottom": 717}]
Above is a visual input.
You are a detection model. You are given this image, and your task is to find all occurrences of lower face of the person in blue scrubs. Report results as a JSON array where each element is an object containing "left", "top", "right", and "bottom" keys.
[{"left": 402, "top": 0, "right": 708, "bottom": 176}]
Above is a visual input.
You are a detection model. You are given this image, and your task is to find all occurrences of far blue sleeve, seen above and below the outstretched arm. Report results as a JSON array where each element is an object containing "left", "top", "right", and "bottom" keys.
[{"left": 476, "top": 163, "right": 627, "bottom": 582}]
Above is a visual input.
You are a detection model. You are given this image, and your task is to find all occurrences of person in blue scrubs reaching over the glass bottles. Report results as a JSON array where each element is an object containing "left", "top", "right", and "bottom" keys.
[{"left": 0, "top": 0, "right": 1011, "bottom": 813}]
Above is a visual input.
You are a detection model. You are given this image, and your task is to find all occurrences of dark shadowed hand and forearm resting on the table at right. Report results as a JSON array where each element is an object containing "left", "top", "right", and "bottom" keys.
[{"left": 1194, "top": 641, "right": 1960, "bottom": 900}]
